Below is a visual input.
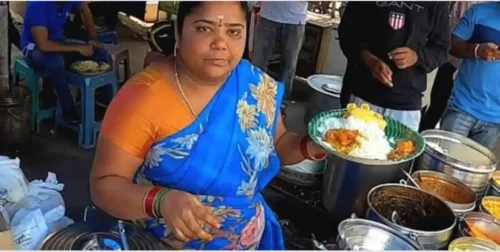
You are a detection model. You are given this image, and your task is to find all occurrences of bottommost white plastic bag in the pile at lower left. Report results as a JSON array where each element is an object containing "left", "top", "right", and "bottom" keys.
[{"left": 11, "top": 208, "right": 49, "bottom": 250}]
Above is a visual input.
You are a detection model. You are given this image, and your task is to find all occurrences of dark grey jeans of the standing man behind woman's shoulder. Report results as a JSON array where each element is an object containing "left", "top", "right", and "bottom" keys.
[{"left": 252, "top": 16, "right": 305, "bottom": 98}]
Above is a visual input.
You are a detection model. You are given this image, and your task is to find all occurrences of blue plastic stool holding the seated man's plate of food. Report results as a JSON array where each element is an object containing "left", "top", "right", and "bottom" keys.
[{"left": 56, "top": 71, "right": 118, "bottom": 149}]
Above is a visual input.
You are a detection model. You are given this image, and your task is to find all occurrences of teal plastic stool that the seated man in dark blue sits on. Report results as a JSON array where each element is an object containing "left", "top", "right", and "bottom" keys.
[{"left": 14, "top": 58, "right": 56, "bottom": 133}]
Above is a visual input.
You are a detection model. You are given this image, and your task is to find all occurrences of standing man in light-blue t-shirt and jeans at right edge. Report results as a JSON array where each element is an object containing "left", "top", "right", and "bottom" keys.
[{"left": 441, "top": 2, "right": 500, "bottom": 149}]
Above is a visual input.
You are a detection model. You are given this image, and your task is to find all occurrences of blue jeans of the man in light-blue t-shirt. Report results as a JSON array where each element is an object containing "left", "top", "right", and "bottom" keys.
[{"left": 441, "top": 104, "right": 500, "bottom": 150}]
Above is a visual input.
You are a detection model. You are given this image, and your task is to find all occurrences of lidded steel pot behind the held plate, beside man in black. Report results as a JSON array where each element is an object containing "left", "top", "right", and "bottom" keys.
[{"left": 304, "top": 74, "right": 342, "bottom": 125}]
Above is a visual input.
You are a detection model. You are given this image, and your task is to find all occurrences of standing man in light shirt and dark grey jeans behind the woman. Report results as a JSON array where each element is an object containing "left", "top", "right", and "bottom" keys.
[{"left": 252, "top": 1, "right": 308, "bottom": 103}]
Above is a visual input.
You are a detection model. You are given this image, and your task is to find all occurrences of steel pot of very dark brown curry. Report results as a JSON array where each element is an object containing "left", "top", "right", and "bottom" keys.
[{"left": 367, "top": 184, "right": 456, "bottom": 250}]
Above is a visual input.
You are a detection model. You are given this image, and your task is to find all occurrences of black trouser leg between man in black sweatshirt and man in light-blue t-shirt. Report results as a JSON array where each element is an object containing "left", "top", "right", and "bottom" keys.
[{"left": 420, "top": 63, "right": 457, "bottom": 131}]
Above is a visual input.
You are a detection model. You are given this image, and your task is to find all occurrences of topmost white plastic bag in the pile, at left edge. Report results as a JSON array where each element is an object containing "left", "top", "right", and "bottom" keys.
[{"left": 0, "top": 156, "right": 28, "bottom": 203}]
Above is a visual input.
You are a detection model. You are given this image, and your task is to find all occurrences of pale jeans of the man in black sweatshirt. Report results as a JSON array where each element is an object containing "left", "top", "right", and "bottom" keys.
[{"left": 351, "top": 96, "right": 422, "bottom": 131}]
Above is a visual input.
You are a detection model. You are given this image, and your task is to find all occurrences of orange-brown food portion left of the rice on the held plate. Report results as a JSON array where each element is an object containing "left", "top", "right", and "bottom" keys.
[{"left": 324, "top": 129, "right": 361, "bottom": 155}]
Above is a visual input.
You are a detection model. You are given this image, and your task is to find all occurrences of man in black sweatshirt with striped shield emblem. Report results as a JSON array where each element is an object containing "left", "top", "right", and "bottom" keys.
[{"left": 338, "top": 2, "right": 450, "bottom": 130}]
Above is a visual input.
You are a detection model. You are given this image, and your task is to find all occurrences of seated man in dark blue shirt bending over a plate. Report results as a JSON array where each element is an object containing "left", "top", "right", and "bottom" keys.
[{"left": 21, "top": 1, "right": 112, "bottom": 122}]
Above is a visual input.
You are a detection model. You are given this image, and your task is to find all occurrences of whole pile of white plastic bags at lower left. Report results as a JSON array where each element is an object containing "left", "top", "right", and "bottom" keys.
[{"left": 0, "top": 156, "right": 73, "bottom": 250}]
